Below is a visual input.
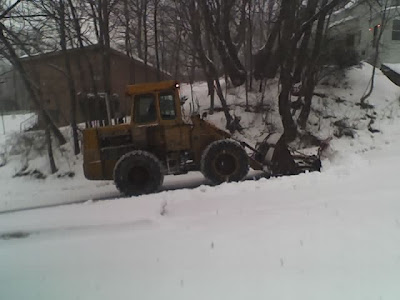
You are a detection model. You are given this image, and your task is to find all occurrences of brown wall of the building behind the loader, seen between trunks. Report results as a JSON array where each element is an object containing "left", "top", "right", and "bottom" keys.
[{"left": 20, "top": 48, "right": 167, "bottom": 126}]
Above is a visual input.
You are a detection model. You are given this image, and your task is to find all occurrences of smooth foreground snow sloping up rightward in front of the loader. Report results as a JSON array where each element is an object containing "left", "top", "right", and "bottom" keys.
[{"left": 0, "top": 135, "right": 400, "bottom": 300}]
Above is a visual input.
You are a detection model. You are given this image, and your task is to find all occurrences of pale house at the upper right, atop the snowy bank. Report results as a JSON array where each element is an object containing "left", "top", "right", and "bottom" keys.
[{"left": 328, "top": 0, "right": 400, "bottom": 66}]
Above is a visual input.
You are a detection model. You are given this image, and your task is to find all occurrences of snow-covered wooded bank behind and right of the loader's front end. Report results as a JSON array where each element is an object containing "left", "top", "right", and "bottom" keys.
[{"left": 182, "top": 63, "right": 400, "bottom": 144}]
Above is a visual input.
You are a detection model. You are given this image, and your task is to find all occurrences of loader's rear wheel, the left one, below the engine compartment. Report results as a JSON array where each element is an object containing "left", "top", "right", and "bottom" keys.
[{"left": 114, "top": 150, "right": 164, "bottom": 196}]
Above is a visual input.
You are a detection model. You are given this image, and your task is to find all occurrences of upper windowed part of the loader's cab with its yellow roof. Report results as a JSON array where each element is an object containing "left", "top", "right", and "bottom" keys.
[{"left": 128, "top": 81, "right": 182, "bottom": 126}]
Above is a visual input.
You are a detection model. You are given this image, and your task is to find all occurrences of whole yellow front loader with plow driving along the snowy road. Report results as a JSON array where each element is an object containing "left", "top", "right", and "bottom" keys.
[{"left": 83, "top": 81, "right": 320, "bottom": 195}]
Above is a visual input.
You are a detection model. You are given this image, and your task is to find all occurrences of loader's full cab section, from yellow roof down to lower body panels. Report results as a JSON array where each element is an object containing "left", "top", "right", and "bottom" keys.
[{"left": 128, "top": 80, "right": 191, "bottom": 154}]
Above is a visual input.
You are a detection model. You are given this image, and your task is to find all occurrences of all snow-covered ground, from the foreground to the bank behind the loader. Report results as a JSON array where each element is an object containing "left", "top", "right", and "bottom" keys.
[{"left": 0, "top": 65, "right": 400, "bottom": 300}]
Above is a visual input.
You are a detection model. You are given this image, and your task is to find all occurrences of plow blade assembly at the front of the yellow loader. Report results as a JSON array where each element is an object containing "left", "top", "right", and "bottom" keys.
[{"left": 253, "top": 133, "right": 321, "bottom": 176}]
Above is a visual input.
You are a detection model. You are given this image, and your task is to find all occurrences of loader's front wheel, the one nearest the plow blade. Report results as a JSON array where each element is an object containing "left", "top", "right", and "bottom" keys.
[{"left": 200, "top": 140, "right": 249, "bottom": 184}]
